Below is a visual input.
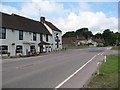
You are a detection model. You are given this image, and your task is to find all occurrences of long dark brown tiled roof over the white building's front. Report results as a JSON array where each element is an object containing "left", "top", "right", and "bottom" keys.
[{"left": 0, "top": 13, "right": 51, "bottom": 35}]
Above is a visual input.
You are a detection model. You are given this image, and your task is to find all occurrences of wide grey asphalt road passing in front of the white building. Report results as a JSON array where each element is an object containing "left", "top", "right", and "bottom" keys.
[{"left": 2, "top": 48, "right": 109, "bottom": 88}]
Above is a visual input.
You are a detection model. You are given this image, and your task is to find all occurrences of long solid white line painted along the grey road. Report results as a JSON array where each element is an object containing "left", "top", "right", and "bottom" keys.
[{"left": 55, "top": 53, "right": 100, "bottom": 90}]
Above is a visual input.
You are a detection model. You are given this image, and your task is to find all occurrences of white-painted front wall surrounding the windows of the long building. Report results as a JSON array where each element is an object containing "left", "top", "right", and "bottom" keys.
[{"left": 0, "top": 29, "right": 52, "bottom": 56}]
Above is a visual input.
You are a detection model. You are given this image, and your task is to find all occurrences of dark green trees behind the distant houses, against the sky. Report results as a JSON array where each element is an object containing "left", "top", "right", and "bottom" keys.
[{"left": 63, "top": 28, "right": 120, "bottom": 46}]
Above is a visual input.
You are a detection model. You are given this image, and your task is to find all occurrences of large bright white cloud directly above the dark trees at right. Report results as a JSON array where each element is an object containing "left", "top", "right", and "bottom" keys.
[{"left": 55, "top": 11, "right": 118, "bottom": 34}]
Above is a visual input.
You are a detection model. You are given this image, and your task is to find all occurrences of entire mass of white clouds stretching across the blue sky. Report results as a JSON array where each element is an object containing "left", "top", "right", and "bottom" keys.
[{"left": 0, "top": 0, "right": 118, "bottom": 34}]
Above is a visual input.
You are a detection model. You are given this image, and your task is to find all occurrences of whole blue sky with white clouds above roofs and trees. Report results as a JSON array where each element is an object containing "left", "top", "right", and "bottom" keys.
[{"left": 0, "top": 0, "right": 118, "bottom": 34}]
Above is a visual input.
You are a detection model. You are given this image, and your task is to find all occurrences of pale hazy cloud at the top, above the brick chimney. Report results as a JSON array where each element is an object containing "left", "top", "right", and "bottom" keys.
[{"left": 21, "top": 0, "right": 64, "bottom": 16}]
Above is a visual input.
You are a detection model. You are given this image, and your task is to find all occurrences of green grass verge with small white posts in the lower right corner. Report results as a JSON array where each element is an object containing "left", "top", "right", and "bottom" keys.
[{"left": 87, "top": 55, "right": 120, "bottom": 88}]
